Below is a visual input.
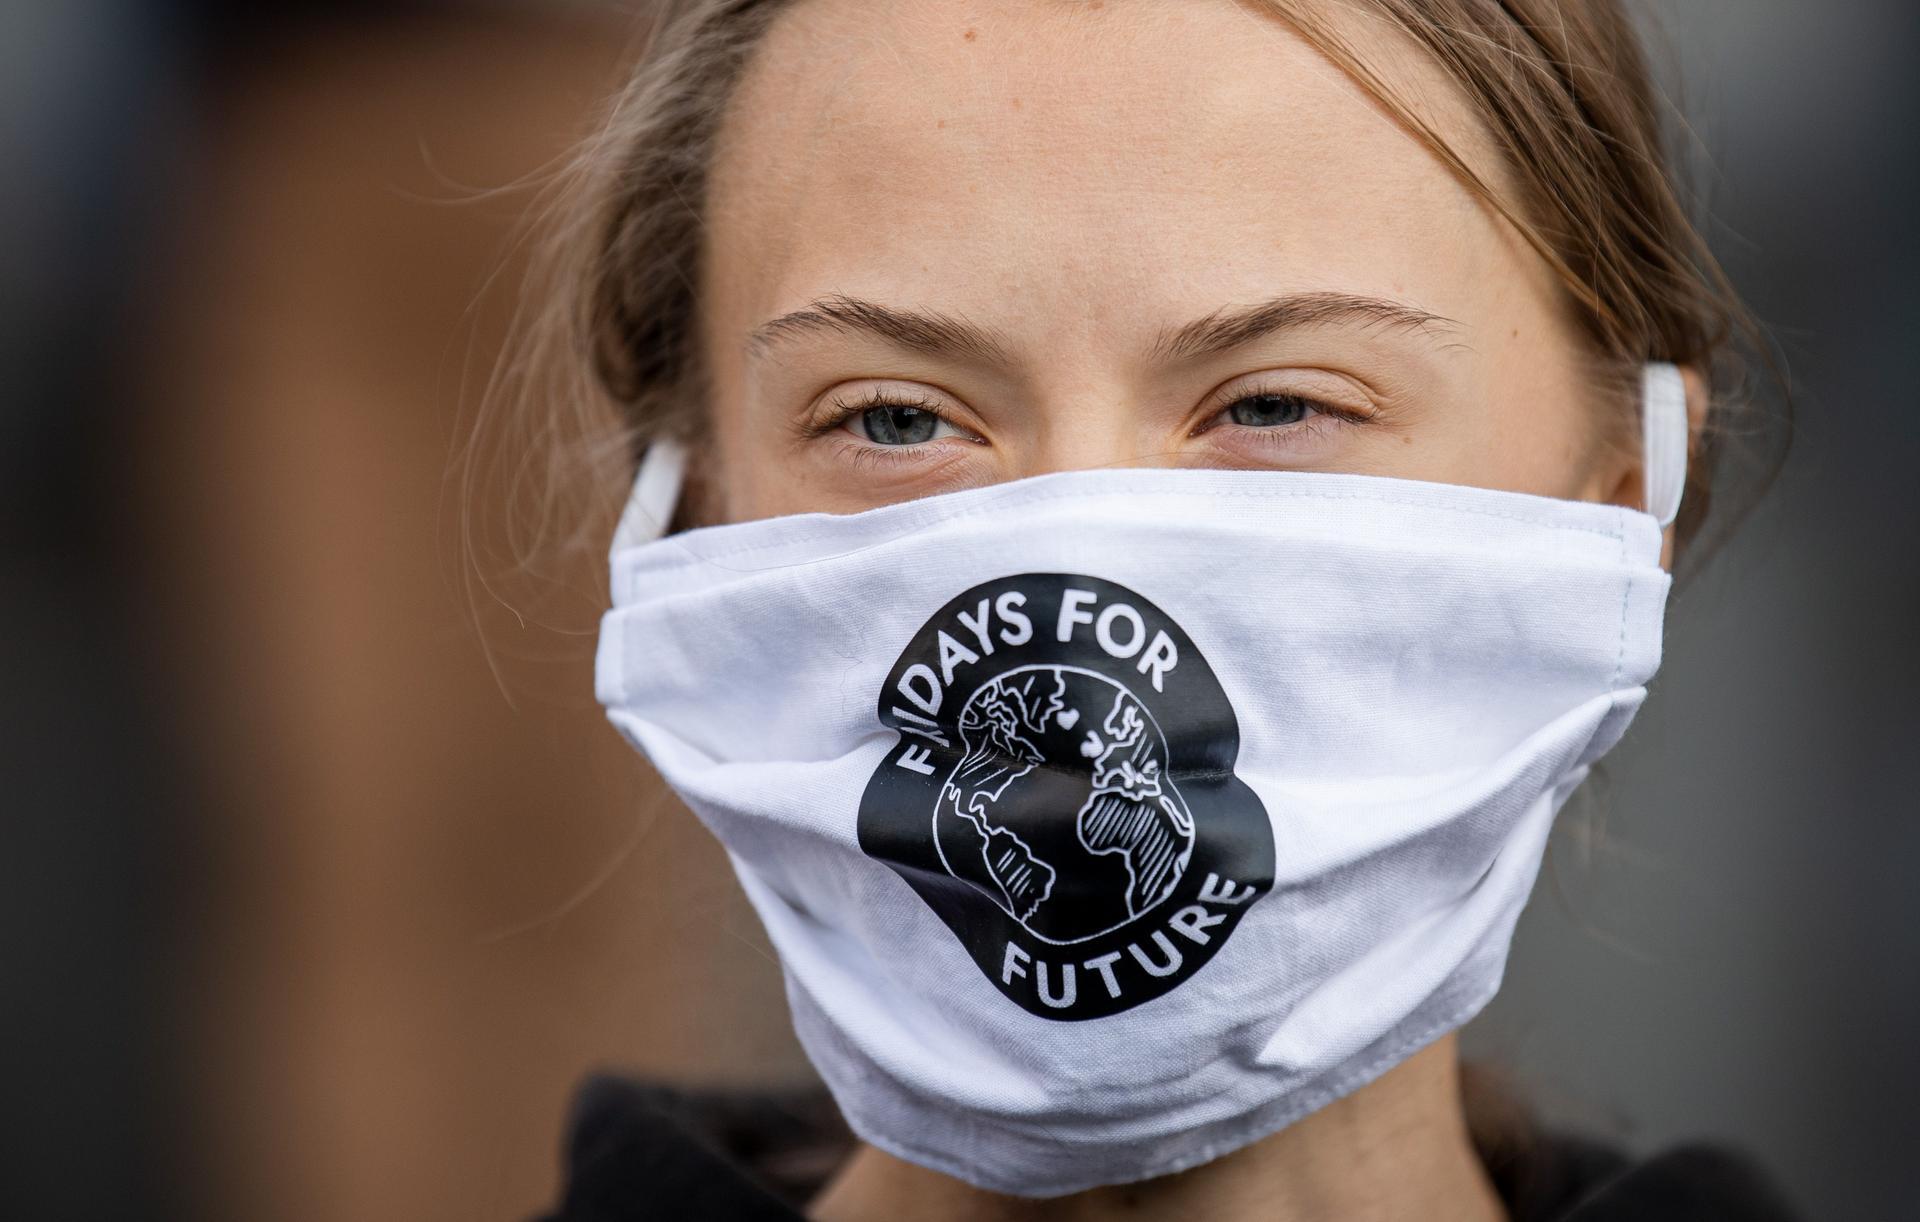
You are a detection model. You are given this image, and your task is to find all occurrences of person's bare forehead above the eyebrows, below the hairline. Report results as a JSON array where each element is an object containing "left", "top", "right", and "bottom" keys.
[{"left": 707, "top": 0, "right": 1500, "bottom": 361}]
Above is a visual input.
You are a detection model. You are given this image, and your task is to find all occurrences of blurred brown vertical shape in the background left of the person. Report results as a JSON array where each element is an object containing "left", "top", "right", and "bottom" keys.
[{"left": 138, "top": 6, "right": 799, "bottom": 1222}]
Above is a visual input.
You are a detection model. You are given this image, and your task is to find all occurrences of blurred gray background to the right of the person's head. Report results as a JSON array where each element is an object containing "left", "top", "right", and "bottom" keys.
[{"left": 1471, "top": 0, "right": 1920, "bottom": 1218}]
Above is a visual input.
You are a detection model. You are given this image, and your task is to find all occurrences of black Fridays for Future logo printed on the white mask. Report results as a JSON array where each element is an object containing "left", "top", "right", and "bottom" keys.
[{"left": 860, "top": 573, "right": 1273, "bottom": 1018}]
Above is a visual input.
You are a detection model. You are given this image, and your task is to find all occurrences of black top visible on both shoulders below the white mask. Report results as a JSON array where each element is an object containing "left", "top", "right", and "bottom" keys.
[{"left": 536, "top": 1074, "right": 1795, "bottom": 1222}]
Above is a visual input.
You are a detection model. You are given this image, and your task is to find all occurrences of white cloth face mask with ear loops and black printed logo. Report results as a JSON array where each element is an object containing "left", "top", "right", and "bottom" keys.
[{"left": 597, "top": 365, "right": 1688, "bottom": 1195}]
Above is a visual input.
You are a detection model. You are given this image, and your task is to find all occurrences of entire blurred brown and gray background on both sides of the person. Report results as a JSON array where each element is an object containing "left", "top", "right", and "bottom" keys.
[{"left": 0, "top": 0, "right": 1920, "bottom": 1220}]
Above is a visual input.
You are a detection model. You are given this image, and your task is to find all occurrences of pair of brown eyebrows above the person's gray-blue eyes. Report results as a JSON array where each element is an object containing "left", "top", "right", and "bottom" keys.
[{"left": 747, "top": 292, "right": 1459, "bottom": 365}]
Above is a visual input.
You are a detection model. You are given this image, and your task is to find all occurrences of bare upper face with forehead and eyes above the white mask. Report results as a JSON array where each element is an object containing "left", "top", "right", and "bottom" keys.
[{"left": 701, "top": 0, "right": 1640, "bottom": 521}]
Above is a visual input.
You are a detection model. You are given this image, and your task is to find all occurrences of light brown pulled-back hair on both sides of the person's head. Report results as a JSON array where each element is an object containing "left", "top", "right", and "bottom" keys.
[{"left": 465, "top": 0, "right": 1791, "bottom": 603}]
